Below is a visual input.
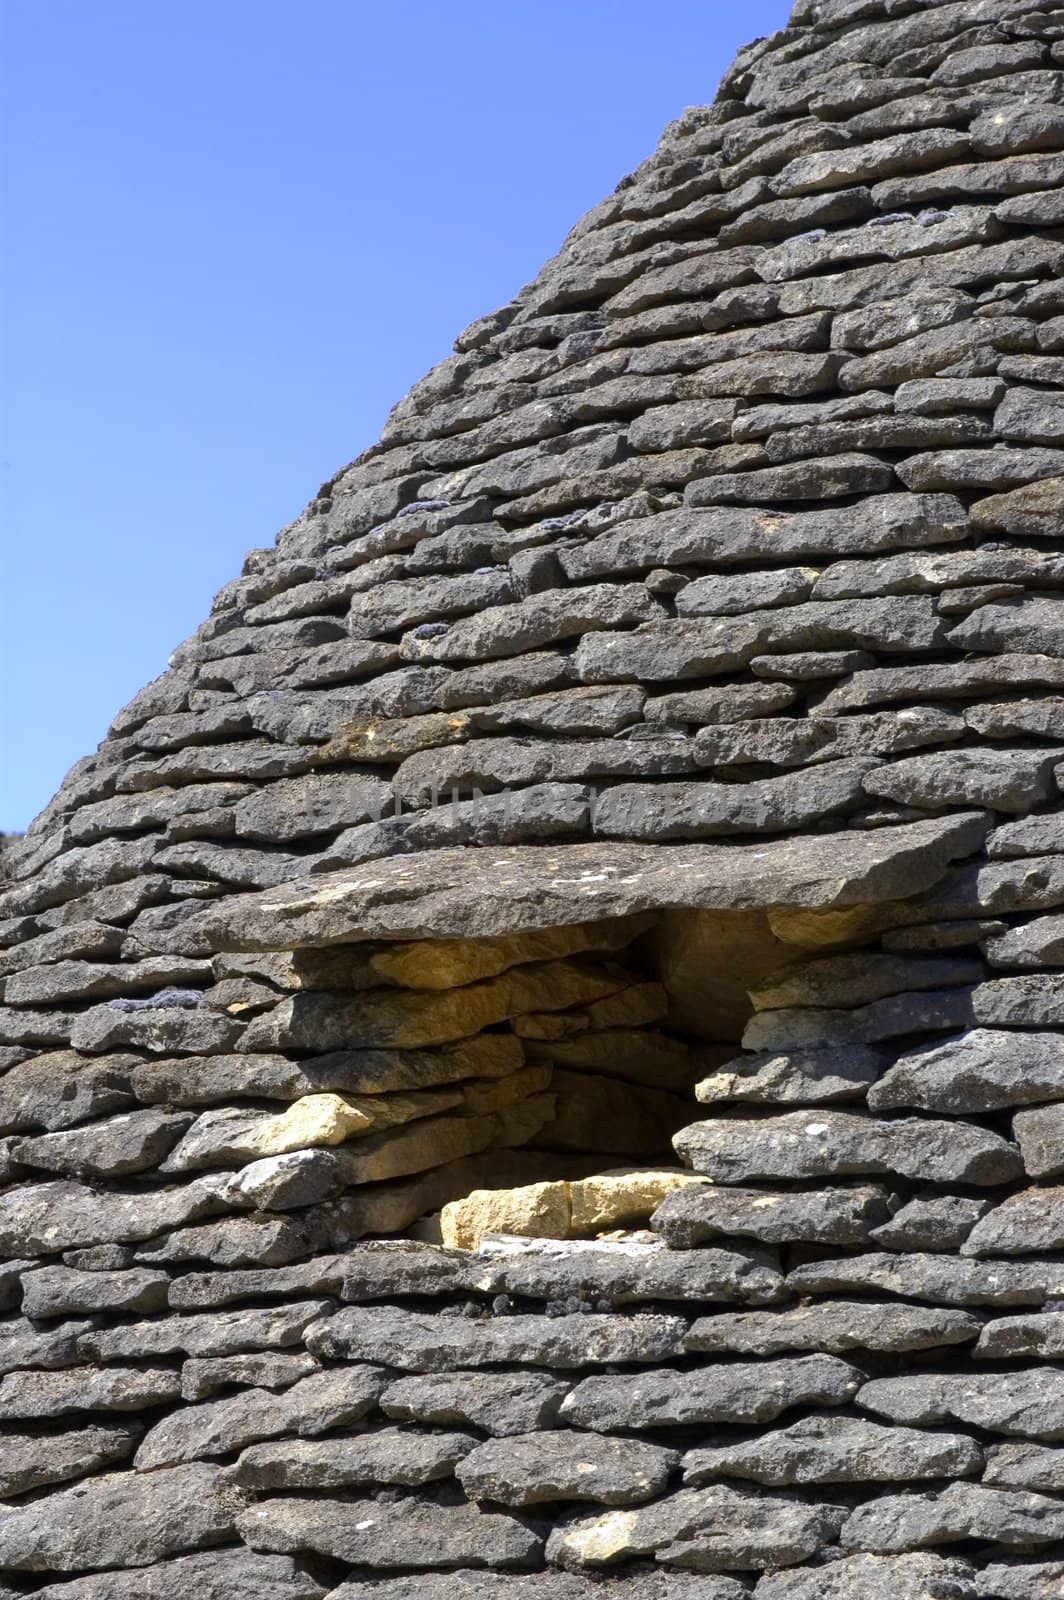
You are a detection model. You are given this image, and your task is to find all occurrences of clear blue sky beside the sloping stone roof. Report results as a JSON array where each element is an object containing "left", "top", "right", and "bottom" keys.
[{"left": 0, "top": 0, "right": 789, "bottom": 829}]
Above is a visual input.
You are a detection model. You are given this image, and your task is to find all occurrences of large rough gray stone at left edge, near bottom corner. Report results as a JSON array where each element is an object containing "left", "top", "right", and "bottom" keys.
[{"left": 0, "top": 1464, "right": 242, "bottom": 1573}]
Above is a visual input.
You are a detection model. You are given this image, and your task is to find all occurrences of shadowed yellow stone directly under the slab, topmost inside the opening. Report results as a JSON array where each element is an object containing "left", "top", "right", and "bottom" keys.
[{"left": 370, "top": 914, "right": 653, "bottom": 989}]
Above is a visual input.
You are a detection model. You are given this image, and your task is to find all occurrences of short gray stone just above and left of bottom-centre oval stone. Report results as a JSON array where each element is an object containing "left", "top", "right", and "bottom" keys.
[{"left": 381, "top": 1371, "right": 573, "bottom": 1438}]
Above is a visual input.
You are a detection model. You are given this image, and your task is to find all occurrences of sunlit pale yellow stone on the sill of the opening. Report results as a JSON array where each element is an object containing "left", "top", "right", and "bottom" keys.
[{"left": 440, "top": 1168, "right": 707, "bottom": 1250}]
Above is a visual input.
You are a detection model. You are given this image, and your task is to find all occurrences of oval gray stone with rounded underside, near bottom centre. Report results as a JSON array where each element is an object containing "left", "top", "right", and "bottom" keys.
[{"left": 456, "top": 1429, "right": 680, "bottom": 1507}]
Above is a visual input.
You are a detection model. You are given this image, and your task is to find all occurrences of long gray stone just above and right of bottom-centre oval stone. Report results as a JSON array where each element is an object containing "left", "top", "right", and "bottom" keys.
[{"left": 562, "top": 1355, "right": 862, "bottom": 1430}]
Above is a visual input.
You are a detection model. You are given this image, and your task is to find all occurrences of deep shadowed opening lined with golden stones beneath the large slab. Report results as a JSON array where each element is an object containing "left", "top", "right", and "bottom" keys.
[{"left": 192, "top": 909, "right": 867, "bottom": 1248}]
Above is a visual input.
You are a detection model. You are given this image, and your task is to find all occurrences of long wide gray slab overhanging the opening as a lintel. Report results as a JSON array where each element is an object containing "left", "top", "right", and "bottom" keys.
[{"left": 170, "top": 813, "right": 986, "bottom": 952}]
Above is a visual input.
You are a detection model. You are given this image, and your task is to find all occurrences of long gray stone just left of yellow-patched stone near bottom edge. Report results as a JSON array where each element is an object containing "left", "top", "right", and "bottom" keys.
[{"left": 237, "top": 1496, "right": 542, "bottom": 1570}]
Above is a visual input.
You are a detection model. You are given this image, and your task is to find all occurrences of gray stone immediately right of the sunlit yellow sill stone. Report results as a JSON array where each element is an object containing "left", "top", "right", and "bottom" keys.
[{"left": 651, "top": 1184, "right": 890, "bottom": 1250}]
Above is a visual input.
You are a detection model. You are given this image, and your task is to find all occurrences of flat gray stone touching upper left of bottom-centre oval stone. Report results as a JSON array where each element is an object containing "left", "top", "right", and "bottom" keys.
[{"left": 229, "top": 1427, "right": 476, "bottom": 1499}]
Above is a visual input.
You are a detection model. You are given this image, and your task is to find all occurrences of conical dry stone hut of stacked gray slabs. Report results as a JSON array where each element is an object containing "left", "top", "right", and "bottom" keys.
[{"left": 0, "top": 0, "right": 1064, "bottom": 1600}]
